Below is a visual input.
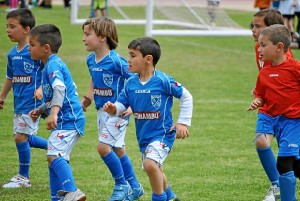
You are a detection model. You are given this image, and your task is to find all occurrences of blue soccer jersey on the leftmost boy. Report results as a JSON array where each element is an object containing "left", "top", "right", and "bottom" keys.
[{"left": 6, "top": 45, "right": 43, "bottom": 114}]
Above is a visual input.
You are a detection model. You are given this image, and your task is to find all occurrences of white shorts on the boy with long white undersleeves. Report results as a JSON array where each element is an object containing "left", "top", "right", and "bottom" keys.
[{"left": 142, "top": 141, "right": 171, "bottom": 170}]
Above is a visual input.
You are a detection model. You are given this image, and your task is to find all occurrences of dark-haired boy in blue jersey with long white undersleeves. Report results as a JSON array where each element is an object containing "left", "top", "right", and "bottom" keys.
[{"left": 103, "top": 37, "right": 193, "bottom": 201}]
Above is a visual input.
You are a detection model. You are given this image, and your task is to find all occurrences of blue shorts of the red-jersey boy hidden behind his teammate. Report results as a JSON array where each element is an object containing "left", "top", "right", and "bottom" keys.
[{"left": 255, "top": 113, "right": 274, "bottom": 135}]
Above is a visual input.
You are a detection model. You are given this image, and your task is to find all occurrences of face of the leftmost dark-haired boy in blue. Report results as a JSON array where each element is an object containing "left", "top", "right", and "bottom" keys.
[{"left": 6, "top": 17, "right": 30, "bottom": 42}]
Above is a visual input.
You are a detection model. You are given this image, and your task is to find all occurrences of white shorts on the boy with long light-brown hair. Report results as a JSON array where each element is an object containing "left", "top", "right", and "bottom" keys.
[{"left": 97, "top": 109, "right": 128, "bottom": 148}]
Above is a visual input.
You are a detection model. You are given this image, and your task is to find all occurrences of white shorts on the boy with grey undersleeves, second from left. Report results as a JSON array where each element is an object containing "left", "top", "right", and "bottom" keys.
[{"left": 47, "top": 130, "right": 80, "bottom": 161}]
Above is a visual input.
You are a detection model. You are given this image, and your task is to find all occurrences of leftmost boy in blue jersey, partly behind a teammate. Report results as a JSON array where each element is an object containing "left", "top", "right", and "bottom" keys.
[{"left": 0, "top": 9, "right": 47, "bottom": 188}]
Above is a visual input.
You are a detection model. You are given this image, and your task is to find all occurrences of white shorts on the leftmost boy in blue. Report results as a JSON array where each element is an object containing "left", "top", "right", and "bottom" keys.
[{"left": 13, "top": 114, "right": 40, "bottom": 135}]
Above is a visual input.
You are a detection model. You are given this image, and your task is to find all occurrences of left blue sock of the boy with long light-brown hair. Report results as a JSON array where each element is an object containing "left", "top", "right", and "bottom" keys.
[{"left": 102, "top": 151, "right": 127, "bottom": 185}]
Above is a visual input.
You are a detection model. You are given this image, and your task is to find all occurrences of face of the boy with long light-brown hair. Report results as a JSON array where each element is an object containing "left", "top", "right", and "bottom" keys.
[{"left": 82, "top": 25, "right": 101, "bottom": 51}]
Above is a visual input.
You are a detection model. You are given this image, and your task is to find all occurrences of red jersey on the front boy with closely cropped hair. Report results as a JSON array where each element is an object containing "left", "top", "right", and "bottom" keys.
[{"left": 255, "top": 59, "right": 300, "bottom": 118}]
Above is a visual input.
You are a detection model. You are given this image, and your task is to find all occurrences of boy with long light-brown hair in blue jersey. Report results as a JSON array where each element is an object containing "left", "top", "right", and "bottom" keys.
[{"left": 82, "top": 17, "right": 144, "bottom": 201}]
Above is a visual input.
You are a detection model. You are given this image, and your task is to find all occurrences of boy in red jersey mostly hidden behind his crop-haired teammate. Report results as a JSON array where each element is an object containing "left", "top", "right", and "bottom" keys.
[{"left": 251, "top": 9, "right": 293, "bottom": 201}]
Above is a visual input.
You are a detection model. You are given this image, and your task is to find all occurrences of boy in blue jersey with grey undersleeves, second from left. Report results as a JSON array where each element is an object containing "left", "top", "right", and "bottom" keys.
[{"left": 29, "top": 24, "right": 86, "bottom": 201}]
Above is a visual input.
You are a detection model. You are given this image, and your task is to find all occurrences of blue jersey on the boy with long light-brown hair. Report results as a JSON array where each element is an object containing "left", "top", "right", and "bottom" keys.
[{"left": 87, "top": 50, "right": 132, "bottom": 110}]
